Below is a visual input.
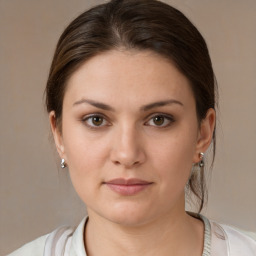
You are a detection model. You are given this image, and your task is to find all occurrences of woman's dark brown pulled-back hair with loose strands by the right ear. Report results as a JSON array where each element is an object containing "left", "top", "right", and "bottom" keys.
[{"left": 46, "top": 0, "right": 217, "bottom": 212}]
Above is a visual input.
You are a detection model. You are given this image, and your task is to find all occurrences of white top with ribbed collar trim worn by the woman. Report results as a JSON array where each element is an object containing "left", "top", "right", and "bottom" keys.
[{"left": 8, "top": 213, "right": 256, "bottom": 256}]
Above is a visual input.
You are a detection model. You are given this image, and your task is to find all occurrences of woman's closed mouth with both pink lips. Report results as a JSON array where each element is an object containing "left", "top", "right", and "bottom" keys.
[{"left": 103, "top": 178, "right": 153, "bottom": 196}]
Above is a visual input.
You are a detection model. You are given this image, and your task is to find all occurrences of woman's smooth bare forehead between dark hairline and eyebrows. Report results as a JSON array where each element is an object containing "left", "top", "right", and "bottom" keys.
[{"left": 64, "top": 50, "right": 194, "bottom": 109}]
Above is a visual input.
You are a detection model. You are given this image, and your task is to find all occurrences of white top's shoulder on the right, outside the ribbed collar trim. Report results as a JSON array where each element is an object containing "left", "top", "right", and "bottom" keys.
[{"left": 211, "top": 221, "right": 256, "bottom": 256}]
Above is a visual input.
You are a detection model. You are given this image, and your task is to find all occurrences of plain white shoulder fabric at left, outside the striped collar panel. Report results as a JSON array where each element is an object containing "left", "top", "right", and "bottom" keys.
[{"left": 7, "top": 234, "right": 49, "bottom": 256}]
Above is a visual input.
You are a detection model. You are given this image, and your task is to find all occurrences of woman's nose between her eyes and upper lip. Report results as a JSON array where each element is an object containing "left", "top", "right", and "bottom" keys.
[{"left": 111, "top": 126, "right": 146, "bottom": 169}]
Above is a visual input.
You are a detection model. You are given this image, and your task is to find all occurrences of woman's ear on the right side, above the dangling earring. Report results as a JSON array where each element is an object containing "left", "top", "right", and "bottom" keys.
[{"left": 193, "top": 108, "right": 216, "bottom": 163}]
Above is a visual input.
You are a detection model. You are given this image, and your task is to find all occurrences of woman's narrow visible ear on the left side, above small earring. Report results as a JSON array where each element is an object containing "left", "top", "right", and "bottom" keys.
[{"left": 49, "top": 111, "right": 66, "bottom": 159}]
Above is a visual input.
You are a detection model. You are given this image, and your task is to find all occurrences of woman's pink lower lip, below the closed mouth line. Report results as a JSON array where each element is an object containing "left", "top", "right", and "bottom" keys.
[{"left": 106, "top": 183, "right": 151, "bottom": 196}]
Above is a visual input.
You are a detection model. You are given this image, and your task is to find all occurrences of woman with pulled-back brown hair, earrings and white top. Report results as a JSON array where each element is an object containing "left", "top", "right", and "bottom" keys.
[{"left": 7, "top": 0, "right": 256, "bottom": 256}]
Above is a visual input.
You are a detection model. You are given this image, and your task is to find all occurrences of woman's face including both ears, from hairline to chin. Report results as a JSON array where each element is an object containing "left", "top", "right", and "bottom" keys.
[{"left": 50, "top": 51, "right": 214, "bottom": 225}]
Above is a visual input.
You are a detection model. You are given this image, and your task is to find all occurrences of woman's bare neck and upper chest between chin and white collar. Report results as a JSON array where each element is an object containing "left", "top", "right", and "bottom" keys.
[{"left": 85, "top": 204, "right": 204, "bottom": 256}]
